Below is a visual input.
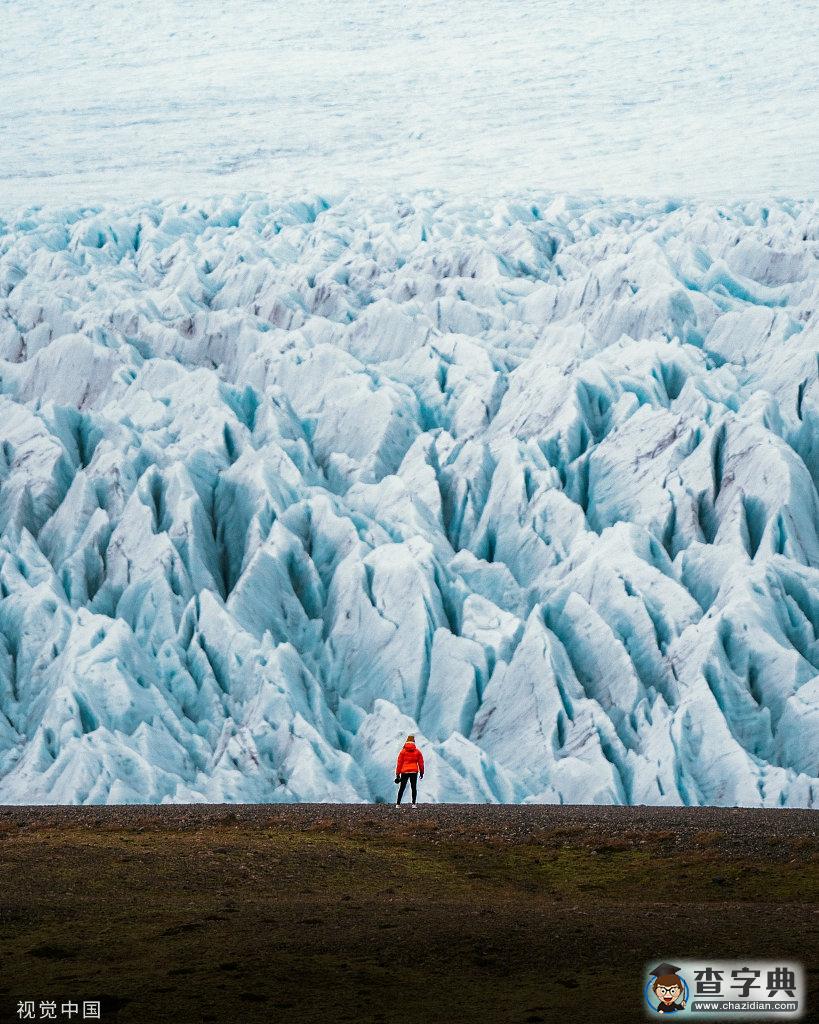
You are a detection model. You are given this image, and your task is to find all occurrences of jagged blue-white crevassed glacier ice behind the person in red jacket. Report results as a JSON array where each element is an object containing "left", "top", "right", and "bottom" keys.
[{"left": 0, "top": 190, "right": 819, "bottom": 807}]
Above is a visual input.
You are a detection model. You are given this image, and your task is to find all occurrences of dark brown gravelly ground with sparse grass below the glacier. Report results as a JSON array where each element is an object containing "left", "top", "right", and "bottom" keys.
[{"left": 0, "top": 805, "right": 819, "bottom": 1024}]
